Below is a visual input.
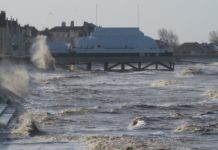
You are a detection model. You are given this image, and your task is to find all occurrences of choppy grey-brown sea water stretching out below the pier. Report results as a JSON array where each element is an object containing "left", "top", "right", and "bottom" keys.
[{"left": 4, "top": 62, "right": 218, "bottom": 149}]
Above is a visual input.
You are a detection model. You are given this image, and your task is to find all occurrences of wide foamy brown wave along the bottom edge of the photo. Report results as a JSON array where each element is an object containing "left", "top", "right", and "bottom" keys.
[{"left": 80, "top": 135, "right": 172, "bottom": 150}]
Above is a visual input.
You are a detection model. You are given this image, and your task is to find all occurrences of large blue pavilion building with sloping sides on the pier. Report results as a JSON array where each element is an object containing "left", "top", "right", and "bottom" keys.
[{"left": 76, "top": 27, "right": 172, "bottom": 55}]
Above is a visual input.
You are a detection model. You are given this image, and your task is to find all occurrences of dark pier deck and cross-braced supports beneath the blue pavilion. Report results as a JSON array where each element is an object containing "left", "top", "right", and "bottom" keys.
[{"left": 54, "top": 54, "right": 175, "bottom": 72}]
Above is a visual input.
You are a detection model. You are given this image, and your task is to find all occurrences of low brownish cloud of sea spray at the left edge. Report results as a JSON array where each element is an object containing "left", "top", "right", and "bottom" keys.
[{"left": 0, "top": 61, "right": 30, "bottom": 97}]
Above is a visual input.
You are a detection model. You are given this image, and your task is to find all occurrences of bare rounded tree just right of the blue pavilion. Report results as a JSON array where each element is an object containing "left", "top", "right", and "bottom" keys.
[{"left": 158, "top": 28, "right": 179, "bottom": 48}]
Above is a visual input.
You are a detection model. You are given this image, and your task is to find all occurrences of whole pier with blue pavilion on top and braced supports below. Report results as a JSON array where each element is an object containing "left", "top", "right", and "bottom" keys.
[{"left": 49, "top": 27, "right": 174, "bottom": 72}]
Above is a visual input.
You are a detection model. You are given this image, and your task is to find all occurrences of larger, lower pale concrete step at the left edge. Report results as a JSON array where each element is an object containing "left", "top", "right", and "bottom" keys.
[{"left": 0, "top": 107, "right": 16, "bottom": 128}]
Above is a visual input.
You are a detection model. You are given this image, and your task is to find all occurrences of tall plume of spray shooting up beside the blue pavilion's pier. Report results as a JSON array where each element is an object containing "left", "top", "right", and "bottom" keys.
[{"left": 31, "top": 35, "right": 55, "bottom": 70}]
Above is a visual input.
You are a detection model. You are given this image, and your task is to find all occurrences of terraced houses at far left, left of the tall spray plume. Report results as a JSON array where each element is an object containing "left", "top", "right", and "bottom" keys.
[{"left": 0, "top": 11, "right": 38, "bottom": 57}]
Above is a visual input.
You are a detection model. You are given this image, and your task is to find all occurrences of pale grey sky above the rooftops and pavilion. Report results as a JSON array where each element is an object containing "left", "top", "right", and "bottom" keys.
[{"left": 0, "top": 0, "right": 218, "bottom": 43}]
